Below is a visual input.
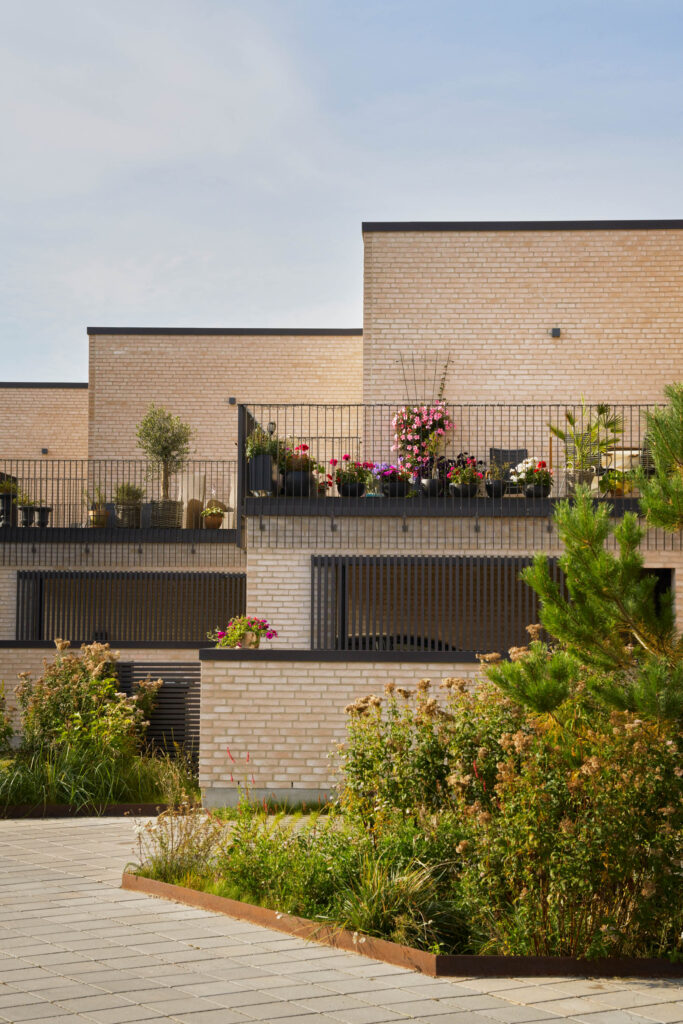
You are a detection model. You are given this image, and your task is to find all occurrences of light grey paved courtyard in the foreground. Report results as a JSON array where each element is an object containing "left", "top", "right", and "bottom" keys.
[{"left": 0, "top": 818, "right": 683, "bottom": 1024}]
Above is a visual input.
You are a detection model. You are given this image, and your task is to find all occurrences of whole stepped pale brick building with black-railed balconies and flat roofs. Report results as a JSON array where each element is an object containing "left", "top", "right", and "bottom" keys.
[{"left": 0, "top": 221, "right": 683, "bottom": 804}]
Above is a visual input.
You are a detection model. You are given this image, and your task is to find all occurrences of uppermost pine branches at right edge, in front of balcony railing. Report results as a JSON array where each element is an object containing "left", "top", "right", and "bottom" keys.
[{"left": 637, "top": 383, "right": 683, "bottom": 532}]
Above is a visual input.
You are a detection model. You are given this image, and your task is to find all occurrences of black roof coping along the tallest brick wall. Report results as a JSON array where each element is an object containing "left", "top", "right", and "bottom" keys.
[{"left": 362, "top": 220, "right": 683, "bottom": 234}]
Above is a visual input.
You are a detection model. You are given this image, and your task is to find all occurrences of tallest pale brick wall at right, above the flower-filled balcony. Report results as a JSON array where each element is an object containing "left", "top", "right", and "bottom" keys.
[{"left": 364, "top": 228, "right": 683, "bottom": 403}]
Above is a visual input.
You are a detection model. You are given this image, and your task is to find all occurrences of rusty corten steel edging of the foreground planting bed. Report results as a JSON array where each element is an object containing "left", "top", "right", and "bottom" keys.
[{"left": 121, "top": 871, "right": 683, "bottom": 978}]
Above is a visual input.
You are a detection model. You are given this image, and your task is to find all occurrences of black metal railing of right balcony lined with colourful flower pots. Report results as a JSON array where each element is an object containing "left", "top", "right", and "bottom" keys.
[{"left": 239, "top": 401, "right": 653, "bottom": 516}]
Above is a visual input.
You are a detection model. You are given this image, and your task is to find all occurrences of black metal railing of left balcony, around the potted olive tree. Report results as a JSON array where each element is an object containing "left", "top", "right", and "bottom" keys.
[{"left": 0, "top": 459, "right": 238, "bottom": 540}]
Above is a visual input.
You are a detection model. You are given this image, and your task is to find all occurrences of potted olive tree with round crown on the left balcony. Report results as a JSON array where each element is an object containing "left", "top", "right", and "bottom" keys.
[{"left": 137, "top": 404, "right": 193, "bottom": 528}]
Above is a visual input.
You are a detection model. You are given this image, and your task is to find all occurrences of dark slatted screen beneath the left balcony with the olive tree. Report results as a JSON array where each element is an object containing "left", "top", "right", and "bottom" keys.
[{"left": 16, "top": 569, "right": 247, "bottom": 643}]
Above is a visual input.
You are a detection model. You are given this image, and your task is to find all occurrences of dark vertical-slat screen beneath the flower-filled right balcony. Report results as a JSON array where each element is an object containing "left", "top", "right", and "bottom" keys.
[{"left": 311, "top": 555, "right": 562, "bottom": 652}]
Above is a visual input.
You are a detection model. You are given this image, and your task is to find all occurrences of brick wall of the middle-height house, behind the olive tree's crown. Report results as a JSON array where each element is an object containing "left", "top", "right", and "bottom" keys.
[{"left": 89, "top": 332, "right": 362, "bottom": 459}]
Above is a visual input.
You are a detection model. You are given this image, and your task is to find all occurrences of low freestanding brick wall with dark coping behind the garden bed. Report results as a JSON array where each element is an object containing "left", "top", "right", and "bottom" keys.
[{"left": 200, "top": 650, "right": 480, "bottom": 807}]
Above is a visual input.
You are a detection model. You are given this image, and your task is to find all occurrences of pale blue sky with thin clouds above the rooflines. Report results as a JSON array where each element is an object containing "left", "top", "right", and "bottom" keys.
[{"left": 0, "top": 0, "right": 683, "bottom": 381}]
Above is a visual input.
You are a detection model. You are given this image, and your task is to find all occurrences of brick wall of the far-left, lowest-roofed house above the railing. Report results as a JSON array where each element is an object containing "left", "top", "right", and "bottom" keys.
[{"left": 0, "top": 384, "right": 88, "bottom": 460}]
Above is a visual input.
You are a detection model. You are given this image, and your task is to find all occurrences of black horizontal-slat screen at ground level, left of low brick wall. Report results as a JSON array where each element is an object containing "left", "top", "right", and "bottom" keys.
[{"left": 117, "top": 660, "right": 201, "bottom": 757}]
